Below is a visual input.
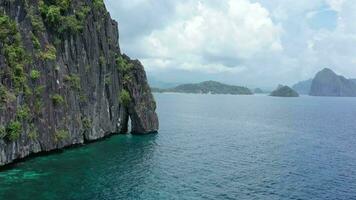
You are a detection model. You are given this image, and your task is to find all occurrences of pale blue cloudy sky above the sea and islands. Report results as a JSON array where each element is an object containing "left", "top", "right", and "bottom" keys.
[{"left": 105, "top": 0, "right": 356, "bottom": 88}]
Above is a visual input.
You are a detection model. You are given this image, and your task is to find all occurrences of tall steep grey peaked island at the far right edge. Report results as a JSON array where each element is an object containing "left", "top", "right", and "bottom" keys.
[{"left": 310, "top": 68, "right": 356, "bottom": 97}]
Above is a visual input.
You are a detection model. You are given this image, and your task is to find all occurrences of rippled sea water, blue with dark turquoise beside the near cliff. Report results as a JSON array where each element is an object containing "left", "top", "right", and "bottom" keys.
[{"left": 0, "top": 94, "right": 356, "bottom": 200}]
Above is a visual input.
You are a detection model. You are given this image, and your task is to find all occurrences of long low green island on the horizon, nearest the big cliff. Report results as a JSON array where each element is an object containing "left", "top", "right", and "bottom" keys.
[{"left": 152, "top": 81, "right": 253, "bottom": 95}]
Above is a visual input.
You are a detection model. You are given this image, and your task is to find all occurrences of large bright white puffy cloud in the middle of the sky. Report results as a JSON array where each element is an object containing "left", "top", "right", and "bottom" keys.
[{"left": 135, "top": 0, "right": 283, "bottom": 73}]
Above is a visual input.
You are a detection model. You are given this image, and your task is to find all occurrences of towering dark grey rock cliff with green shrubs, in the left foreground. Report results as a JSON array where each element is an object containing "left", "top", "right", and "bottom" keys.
[{"left": 0, "top": 0, "right": 158, "bottom": 166}]
